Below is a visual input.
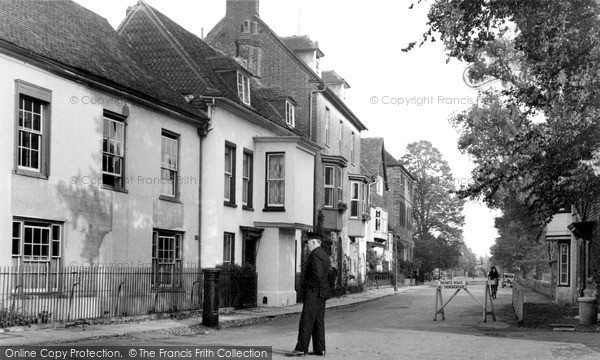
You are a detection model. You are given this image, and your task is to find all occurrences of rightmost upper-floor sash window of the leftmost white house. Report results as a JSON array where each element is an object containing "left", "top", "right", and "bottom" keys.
[{"left": 160, "top": 130, "right": 179, "bottom": 197}]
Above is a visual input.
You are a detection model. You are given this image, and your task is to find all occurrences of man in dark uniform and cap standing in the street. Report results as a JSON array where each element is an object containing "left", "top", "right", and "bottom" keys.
[{"left": 290, "top": 232, "right": 331, "bottom": 356}]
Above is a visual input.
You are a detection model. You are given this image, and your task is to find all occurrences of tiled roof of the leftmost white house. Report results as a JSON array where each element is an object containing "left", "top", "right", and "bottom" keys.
[{"left": 0, "top": 0, "right": 206, "bottom": 118}]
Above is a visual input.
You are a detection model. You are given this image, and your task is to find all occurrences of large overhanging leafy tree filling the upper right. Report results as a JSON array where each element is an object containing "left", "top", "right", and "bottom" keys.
[{"left": 407, "top": 0, "right": 600, "bottom": 292}]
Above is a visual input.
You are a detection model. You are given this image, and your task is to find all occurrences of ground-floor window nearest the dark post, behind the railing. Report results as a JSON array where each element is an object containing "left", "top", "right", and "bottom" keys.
[{"left": 152, "top": 229, "right": 183, "bottom": 287}]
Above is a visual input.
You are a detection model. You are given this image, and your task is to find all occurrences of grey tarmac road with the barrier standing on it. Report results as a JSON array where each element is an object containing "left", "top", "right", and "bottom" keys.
[{"left": 61, "top": 286, "right": 600, "bottom": 360}]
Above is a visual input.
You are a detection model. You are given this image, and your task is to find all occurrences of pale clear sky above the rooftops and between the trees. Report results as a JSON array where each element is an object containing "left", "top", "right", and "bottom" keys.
[{"left": 76, "top": 0, "right": 498, "bottom": 255}]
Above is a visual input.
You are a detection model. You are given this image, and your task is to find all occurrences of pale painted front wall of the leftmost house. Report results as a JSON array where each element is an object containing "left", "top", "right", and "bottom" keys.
[{"left": 0, "top": 55, "right": 200, "bottom": 266}]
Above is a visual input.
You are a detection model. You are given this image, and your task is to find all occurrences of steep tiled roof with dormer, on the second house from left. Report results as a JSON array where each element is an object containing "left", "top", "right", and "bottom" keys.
[{"left": 119, "top": 1, "right": 295, "bottom": 131}]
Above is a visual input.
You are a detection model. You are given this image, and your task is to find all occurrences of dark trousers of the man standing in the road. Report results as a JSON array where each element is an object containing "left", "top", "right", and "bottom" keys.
[{"left": 296, "top": 288, "right": 326, "bottom": 352}]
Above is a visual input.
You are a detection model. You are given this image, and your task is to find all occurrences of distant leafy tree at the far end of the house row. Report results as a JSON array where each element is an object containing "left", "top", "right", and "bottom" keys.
[{"left": 402, "top": 141, "right": 464, "bottom": 274}]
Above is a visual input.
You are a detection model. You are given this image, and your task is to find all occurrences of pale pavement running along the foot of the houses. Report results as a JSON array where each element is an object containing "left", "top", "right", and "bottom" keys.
[{"left": 0, "top": 285, "right": 410, "bottom": 346}]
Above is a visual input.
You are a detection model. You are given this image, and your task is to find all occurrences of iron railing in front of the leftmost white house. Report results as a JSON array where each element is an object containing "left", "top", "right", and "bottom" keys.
[{"left": 0, "top": 266, "right": 202, "bottom": 323}]
